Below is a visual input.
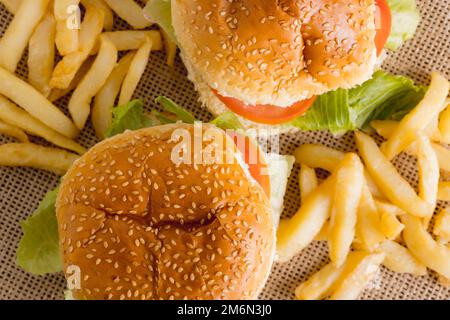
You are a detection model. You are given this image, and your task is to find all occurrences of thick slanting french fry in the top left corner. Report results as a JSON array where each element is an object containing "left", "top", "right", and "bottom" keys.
[{"left": 0, "top": 0, "right": 49, "bottom": 72}]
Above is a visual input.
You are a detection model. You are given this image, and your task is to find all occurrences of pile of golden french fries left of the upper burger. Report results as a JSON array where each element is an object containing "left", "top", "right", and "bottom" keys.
[{"left": 0, "top": 0, "right": 172, "bottom": 174}]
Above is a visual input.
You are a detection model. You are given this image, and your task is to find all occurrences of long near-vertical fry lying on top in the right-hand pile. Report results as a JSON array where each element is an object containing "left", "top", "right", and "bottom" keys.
[{"left": 328, "top": 153, "right": 365, "bottom": 266}]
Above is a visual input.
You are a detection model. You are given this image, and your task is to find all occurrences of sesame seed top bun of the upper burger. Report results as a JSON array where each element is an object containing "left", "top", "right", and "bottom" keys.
[{"left": 172, "top": 0, "right": 376, "bottom": 107}]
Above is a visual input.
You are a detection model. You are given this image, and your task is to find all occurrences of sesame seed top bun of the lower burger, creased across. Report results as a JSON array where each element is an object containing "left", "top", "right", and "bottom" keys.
[{"left": 56, "top": 124, "right": 275, "bottom": 299}]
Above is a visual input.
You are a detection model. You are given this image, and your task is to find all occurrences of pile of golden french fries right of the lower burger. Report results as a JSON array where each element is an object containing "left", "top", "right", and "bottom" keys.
[{"left": 277, "top": 73, "right": 450, "bottom": 300}]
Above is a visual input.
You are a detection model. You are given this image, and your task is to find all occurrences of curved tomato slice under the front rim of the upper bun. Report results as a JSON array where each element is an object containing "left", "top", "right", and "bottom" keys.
[{"left": 213, "top": 90, "right": 316, "bottom": 124}]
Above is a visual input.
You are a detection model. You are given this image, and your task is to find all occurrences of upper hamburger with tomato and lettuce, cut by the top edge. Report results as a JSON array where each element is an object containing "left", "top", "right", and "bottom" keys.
[{"left": 144, "top": 0, "right": 419, "bottom": 132}]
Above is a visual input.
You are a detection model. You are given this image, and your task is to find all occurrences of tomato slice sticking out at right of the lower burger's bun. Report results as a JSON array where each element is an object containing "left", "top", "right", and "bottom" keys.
[{"left": 228, "top": 132, "right": 270, "bottom": 198}]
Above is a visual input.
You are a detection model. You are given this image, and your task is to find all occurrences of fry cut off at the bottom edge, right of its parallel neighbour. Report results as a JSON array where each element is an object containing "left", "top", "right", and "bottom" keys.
[{"left": 330, "top": 253, "right": 384, "bottom": 300}]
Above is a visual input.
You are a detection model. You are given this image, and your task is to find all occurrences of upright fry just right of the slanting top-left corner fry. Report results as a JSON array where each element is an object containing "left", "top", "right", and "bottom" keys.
[{"left": 28, "top": 13, "right": 56, "bottom": 97}]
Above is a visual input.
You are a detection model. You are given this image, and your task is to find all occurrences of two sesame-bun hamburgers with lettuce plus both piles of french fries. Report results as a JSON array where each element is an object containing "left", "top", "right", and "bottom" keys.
[{"left": 0, "top": 0, "right": 450, "bottom": 300}]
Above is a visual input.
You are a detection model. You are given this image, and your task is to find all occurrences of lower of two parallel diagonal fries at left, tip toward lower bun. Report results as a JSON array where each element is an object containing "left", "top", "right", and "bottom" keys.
[{"left": 0, "top": 95, "right": 86, "bottom": 154}]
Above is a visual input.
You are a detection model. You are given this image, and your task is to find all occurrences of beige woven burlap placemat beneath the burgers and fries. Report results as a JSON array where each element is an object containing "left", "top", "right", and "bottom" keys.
[{"left": 0, "top": 0, "right": 450, "bottom": 299}]
